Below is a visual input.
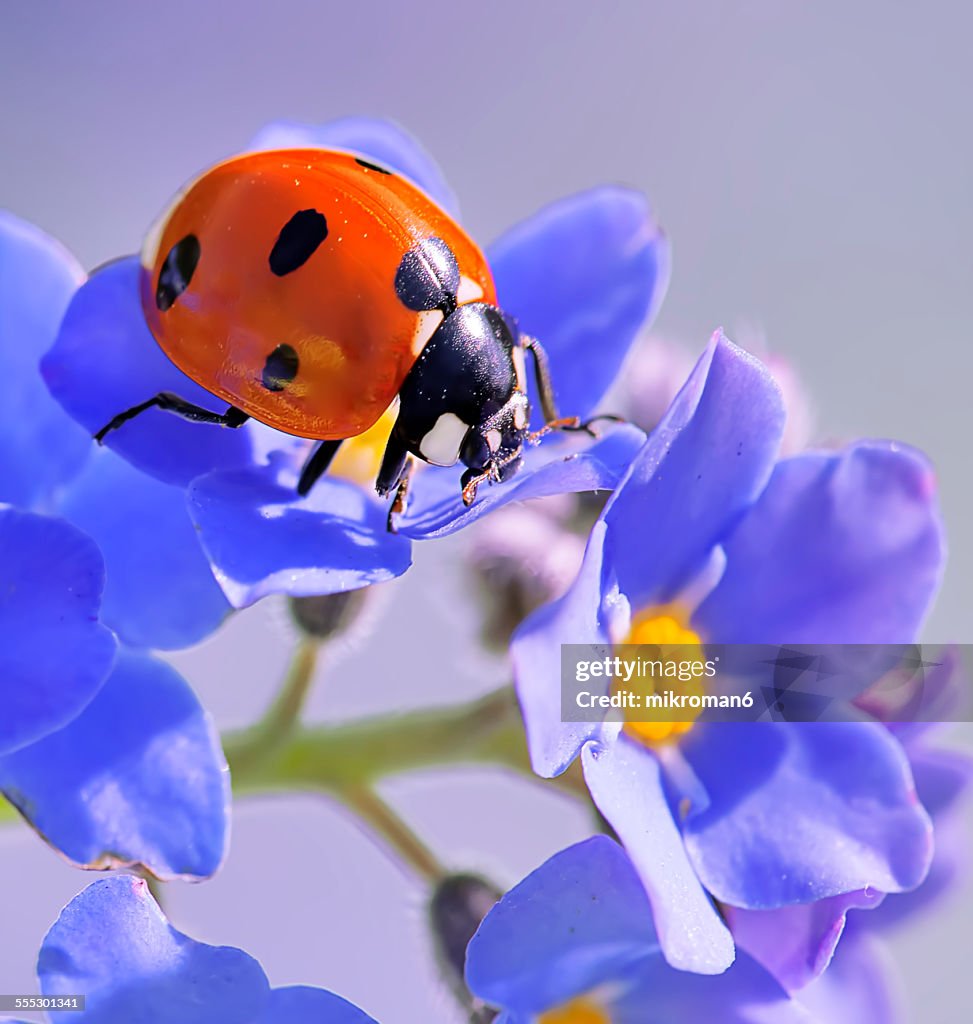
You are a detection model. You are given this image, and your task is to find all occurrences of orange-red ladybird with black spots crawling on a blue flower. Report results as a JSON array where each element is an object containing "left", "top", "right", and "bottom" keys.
[{"left": 95, "top": 148, "right": 589, "bottom": 526}]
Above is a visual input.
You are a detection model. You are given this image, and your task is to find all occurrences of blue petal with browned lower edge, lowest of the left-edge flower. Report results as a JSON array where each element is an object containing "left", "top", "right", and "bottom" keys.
[{"left": 0, "top": 654, "right": 229, "bottom": 879}]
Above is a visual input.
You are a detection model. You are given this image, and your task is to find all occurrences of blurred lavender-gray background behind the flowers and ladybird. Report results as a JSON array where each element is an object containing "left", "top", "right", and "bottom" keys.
[{"left": 0, "top": 0, "right": 973, "bottom": 1024}]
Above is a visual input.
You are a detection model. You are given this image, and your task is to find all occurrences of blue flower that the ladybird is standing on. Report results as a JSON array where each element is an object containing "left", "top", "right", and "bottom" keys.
[{"left": 36, "top": 118, "right": 669, "bottom": 607}]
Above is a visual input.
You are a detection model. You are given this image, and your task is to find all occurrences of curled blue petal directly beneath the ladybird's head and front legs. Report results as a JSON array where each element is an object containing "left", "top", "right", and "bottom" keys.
[{"left": 398, "top": 424, "right": 645, "bottom": 541}]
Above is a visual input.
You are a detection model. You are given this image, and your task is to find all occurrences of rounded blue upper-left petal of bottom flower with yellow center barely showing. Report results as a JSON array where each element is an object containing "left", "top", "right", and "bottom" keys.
[{"left": 466, "top": 836, "right": 658, "bottom": 1014}]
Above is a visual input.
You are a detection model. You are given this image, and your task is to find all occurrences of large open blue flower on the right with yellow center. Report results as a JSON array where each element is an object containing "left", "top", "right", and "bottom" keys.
[{"left": 512, "top": 335, "right": 942, "bottom": 973}]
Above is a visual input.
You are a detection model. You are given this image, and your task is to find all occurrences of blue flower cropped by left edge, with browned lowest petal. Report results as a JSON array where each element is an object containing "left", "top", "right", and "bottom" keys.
[{"left": 0, "top": 214, "right": 236, "bottom": 878}]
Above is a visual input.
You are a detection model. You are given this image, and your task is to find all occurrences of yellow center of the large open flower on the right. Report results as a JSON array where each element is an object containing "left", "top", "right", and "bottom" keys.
[{"left": 615, "top": 608, "right": 706, "bottom": 746}]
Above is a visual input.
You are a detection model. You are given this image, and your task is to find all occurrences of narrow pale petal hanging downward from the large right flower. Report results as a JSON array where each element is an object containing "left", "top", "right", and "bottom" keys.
[{"left": 582, "top": 736, "right": 733, "bottom": 974}]
